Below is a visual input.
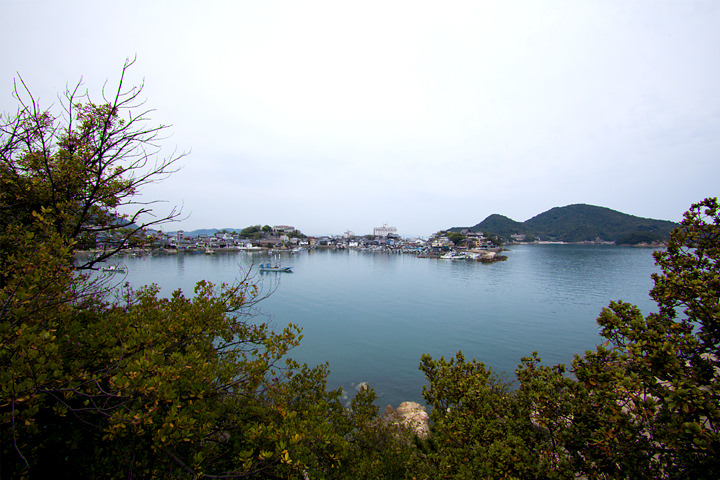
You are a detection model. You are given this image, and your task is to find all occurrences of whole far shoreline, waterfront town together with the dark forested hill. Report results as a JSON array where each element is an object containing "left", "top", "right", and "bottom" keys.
[{"left": 91, "top": 204, "right": 678, "bottom": 262}]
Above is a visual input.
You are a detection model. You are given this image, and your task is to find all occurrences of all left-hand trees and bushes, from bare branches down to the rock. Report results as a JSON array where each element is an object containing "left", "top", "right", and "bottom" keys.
[{"left": 0, "top": 65, "right": 428, "bottom": 478}]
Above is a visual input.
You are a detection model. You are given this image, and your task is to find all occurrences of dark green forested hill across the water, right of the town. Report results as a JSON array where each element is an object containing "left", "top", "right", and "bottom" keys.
[{"left": 451, "top": 204, "right": 678, "bottom": 244}]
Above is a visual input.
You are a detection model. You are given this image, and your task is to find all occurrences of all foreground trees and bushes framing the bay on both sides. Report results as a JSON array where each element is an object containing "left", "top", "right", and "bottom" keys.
[{"left": 0, "top": 66, "right": 720, "bottom": 479}]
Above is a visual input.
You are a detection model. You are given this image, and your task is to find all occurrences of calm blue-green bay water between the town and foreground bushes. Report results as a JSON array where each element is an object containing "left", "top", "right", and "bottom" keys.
[{"left": 95, "top": 245, "right": 657, "bottom": 407}]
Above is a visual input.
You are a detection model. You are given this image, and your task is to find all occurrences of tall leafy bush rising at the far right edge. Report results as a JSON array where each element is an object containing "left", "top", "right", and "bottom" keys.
[{"left": 577, "top": 198, "right": 720, "bottom": 478}]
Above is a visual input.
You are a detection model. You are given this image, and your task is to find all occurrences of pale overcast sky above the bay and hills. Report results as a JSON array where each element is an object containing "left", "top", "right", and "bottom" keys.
[{"left": 0, "top": 0, "right": 720, "bottom": 236}]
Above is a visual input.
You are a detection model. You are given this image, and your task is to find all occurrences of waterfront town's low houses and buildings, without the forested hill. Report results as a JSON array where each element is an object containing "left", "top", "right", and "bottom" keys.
[{"left": 144, "top": 225, "right": 493, "bottom": 253}]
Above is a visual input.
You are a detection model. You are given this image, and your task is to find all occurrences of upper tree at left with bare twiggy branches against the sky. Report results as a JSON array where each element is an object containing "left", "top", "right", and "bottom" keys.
[{"left": 0, "top": 58, "right": 187, "bottom": 269}]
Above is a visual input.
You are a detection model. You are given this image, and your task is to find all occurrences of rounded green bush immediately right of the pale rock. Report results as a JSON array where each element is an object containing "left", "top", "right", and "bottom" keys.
[{"left": 420, "top": 352, "right": 536, "bottom": 479}]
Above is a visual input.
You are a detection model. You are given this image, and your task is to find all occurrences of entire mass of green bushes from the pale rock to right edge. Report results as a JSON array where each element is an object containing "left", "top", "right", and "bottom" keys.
[{"left": 420, "top": 198, "right": 720, "bottom": 479}]
